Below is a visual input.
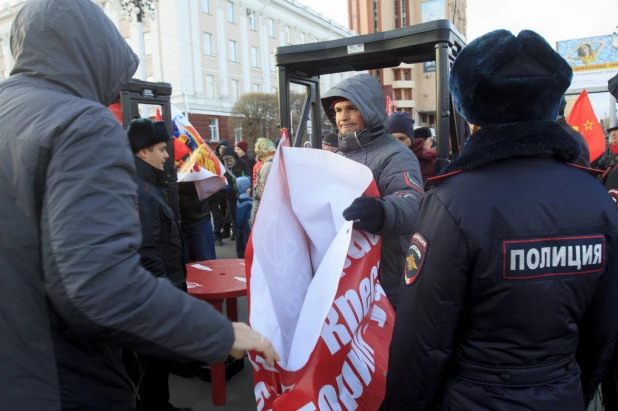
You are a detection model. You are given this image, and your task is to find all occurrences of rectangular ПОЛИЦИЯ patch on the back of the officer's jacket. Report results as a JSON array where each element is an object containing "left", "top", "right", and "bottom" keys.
[{"left": 502, "top": 234, "right": 605, "bottom": 281}]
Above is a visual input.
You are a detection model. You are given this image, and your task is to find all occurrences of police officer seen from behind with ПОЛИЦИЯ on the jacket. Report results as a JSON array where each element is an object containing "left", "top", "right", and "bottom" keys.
[{"left": 385, "top": 30, "right": 618, "bottom": 411}]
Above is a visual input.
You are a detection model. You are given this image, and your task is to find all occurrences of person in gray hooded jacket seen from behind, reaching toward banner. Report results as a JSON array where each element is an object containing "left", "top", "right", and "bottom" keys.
[{"left": 0, "top": 0, "right": 276, "bottom": 411}]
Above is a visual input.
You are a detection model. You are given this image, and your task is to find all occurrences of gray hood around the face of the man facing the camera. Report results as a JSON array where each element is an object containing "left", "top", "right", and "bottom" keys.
[{"left": 322, "top": 74, "right": 387, "bottom": 132}]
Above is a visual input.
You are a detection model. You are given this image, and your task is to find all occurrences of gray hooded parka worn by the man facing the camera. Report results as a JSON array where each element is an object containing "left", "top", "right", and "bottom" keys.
[{"left": 322, "top": 74, "right": 424, "bottom": 307}]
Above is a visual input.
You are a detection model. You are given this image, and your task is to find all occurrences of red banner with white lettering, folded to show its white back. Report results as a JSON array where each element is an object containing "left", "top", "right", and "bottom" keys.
[{"left": 245, "top": 130, "right": 394, "bottom": 411}]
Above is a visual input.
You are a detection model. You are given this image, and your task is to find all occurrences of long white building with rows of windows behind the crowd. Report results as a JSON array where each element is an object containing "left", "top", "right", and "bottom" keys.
[{"left": 0, "top": 0, "right": 355, "bottom": 142}]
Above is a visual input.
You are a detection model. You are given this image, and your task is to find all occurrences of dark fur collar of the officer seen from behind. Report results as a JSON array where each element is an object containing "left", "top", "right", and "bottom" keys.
[{"left": 439, "top": 121, "right": 581, "bottom": 175}]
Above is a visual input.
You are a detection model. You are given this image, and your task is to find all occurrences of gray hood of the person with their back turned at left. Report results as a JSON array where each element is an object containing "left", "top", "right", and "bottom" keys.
[{"left": 11, "top": 0, "right": 139, "bottom": 106}]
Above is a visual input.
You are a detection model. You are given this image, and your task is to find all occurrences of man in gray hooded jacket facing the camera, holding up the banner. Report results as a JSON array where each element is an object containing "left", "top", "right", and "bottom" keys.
[{"left": 322, "top": 74, "right": 423, "bottom": 308}]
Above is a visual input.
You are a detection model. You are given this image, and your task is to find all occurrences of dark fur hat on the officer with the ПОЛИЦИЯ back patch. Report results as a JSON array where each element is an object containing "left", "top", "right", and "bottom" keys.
[{"left": 449, "top": 30, "right": 573, "bottom": 126}]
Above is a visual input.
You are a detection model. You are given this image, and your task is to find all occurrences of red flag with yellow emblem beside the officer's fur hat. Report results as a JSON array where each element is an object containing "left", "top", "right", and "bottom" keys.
[{"left": 567, "top": 90, "right": 606, "bottom": 162}]
